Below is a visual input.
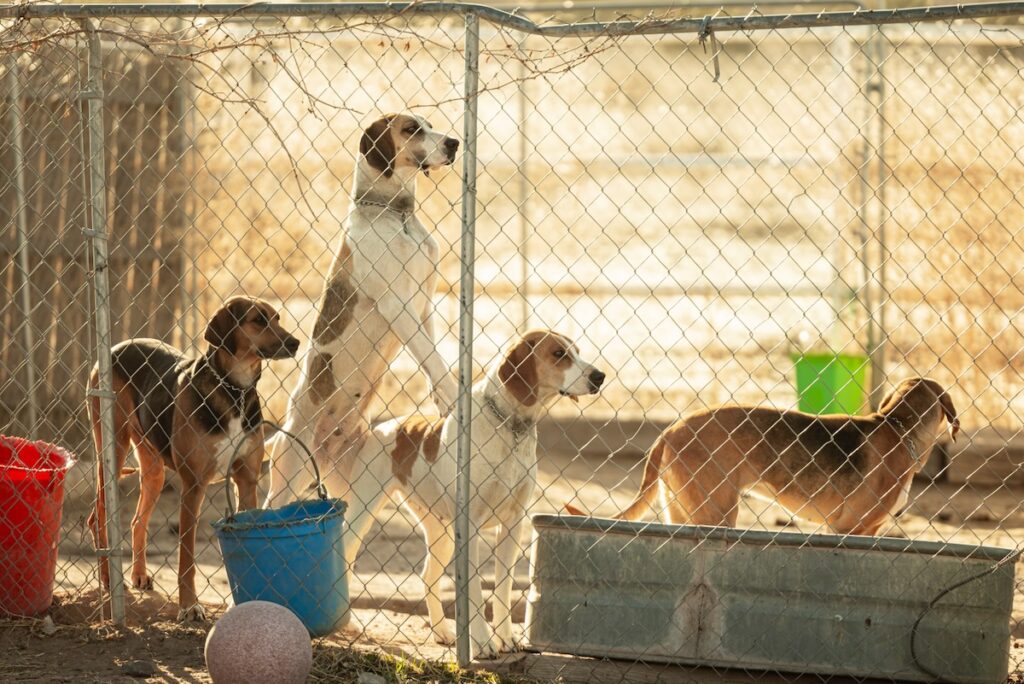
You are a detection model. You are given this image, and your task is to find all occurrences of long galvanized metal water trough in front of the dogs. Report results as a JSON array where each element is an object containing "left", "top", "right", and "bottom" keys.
[{"left": 526, "top": 515, "right": 1020, "bottom": 683}]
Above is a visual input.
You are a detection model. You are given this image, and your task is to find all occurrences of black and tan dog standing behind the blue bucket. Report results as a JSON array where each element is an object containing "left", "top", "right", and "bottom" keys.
[{"left": 89, "top": 297, "right": 299, "bottom": 621}]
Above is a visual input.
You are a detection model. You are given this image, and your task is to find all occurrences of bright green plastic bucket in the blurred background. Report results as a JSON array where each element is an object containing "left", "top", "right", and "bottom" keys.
[{"left": 792, "top": 353, "right": 869, "bottom": 414}]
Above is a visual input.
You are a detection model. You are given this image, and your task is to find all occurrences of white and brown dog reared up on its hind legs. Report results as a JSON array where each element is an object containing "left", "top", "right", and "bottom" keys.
[{"left": 267, "top": 114, "right": 459, "bottom": 507}]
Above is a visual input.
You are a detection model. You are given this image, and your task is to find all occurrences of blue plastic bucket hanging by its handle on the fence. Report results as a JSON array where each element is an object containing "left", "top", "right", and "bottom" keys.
[{"left": 213, "top": 499, "right": 349, "bottom": 637}]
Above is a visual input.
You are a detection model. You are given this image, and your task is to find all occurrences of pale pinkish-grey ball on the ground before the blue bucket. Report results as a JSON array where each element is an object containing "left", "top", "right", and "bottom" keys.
[{"left": 205, "top": 601, "right": 313, "bottom": 684}]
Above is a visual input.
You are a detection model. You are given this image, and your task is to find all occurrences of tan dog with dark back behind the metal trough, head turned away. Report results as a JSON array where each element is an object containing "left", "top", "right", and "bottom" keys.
[{"left": 565, "top": 378, "right": 959, "bottom": 535}]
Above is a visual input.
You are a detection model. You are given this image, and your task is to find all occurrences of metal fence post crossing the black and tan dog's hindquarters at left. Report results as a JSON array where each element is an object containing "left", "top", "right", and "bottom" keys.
[{"left": 82, "top": 19, "right": 125, "bottom": 625}]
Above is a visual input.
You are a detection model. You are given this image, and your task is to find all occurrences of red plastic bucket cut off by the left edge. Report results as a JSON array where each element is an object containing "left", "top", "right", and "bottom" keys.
[{"left": 0, "top": 435, "right": 75, "bottom": 615}]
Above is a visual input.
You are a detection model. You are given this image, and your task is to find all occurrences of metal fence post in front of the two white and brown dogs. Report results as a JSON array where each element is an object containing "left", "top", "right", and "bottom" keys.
[{"left": 455, "top": 7, "right": 480, "bottom": 666}]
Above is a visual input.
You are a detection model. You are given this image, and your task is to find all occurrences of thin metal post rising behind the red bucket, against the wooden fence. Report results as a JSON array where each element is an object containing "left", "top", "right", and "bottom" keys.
[{"left": 7, "top": 52, "right": 39, "bottom": 439}]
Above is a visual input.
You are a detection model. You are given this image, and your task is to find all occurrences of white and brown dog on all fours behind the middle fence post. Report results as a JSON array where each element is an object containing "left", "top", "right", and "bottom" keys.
[{"left": 326, "top": 331, "right": 605, "bottom": 658}]
